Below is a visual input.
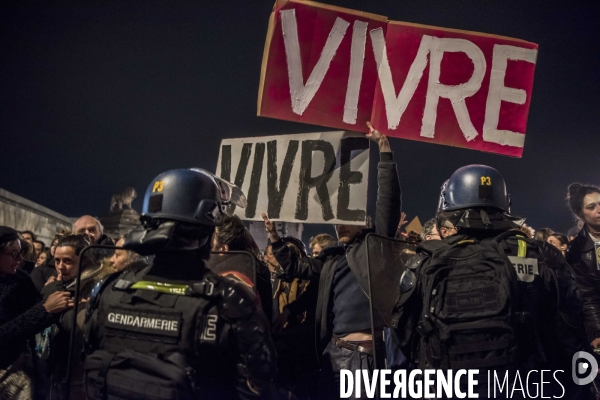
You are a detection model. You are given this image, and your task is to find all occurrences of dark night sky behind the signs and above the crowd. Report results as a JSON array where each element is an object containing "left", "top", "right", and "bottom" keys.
[{"left": 0, "top": 0, "right": 600, "bottom": 241}]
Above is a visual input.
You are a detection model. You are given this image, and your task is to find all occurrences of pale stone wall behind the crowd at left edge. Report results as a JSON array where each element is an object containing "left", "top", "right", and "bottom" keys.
[{"left": 0, "top": 189, "right": 73, "bottom": 246}]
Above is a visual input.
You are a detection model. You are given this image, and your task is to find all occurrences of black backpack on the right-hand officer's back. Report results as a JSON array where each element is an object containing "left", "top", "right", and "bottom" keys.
[{"left": 400, "top": 236, "right": 521, "bottom": 370}]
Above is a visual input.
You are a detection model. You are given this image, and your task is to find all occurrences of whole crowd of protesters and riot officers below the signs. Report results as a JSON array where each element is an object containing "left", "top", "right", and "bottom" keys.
[{"left": 0, "top": 127, "right": 600, "bottom": 399}]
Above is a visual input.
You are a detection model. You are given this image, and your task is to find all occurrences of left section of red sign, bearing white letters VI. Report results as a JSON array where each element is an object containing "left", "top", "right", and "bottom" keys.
[{"left": 258, "top": 1, "right": 387, "bottom": 131}]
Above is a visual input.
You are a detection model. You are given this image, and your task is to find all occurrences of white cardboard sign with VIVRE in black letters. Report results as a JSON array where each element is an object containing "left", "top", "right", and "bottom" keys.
[{"left": 216, "top": 131, "right": 369, "bottom": 225}]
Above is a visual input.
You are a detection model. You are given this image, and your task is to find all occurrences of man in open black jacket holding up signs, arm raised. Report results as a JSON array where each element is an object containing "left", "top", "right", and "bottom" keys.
[{"left": 263, "top": 124, "right": 401, "bottom": 398}]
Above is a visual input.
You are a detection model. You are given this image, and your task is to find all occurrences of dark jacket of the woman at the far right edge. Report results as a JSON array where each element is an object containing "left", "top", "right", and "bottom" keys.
[{"left": 567, "top": 227, "right": 600, "bottom": 341}]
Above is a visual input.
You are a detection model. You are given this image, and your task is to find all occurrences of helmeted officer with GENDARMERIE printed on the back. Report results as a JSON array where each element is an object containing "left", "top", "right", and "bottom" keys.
[{"left": 85, "top": 169, "right": 277, "bottom": 400}]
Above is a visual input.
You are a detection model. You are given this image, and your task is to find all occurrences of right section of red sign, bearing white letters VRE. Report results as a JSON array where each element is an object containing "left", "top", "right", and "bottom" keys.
[{"left": 370, "top": 22, "right": 537, "bottom": 157}]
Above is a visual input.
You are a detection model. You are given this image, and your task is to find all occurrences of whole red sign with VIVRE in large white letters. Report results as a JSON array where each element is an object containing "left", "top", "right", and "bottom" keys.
[{"left": 258, "top": 0, "right": 537, "bottom": 157}]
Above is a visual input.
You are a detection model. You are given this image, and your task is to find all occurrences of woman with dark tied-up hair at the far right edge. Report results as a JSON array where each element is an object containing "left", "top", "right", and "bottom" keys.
[{"left": 567, "top": 183, "right": 600, "bottom": 348}]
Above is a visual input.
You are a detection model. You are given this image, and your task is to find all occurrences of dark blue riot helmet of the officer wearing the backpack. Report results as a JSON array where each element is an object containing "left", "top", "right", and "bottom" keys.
[{"left": 438, "top": 164, "right": 510, "bottom": 213}]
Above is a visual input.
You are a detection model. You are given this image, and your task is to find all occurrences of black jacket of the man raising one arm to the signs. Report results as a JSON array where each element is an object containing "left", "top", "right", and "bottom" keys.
[{"left": 273, "top": 152, "right": 401, "bottom": 354}]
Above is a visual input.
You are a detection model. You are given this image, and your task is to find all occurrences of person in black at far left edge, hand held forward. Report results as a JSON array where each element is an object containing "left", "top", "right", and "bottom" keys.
[{"left": 0, "top": 226, "right": 73, "bottom": 399}]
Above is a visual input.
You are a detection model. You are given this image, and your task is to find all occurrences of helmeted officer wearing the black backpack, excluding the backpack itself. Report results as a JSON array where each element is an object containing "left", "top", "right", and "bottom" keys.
[{"left": 394, "top": 165, "right": 586, "bottom": 399}]
